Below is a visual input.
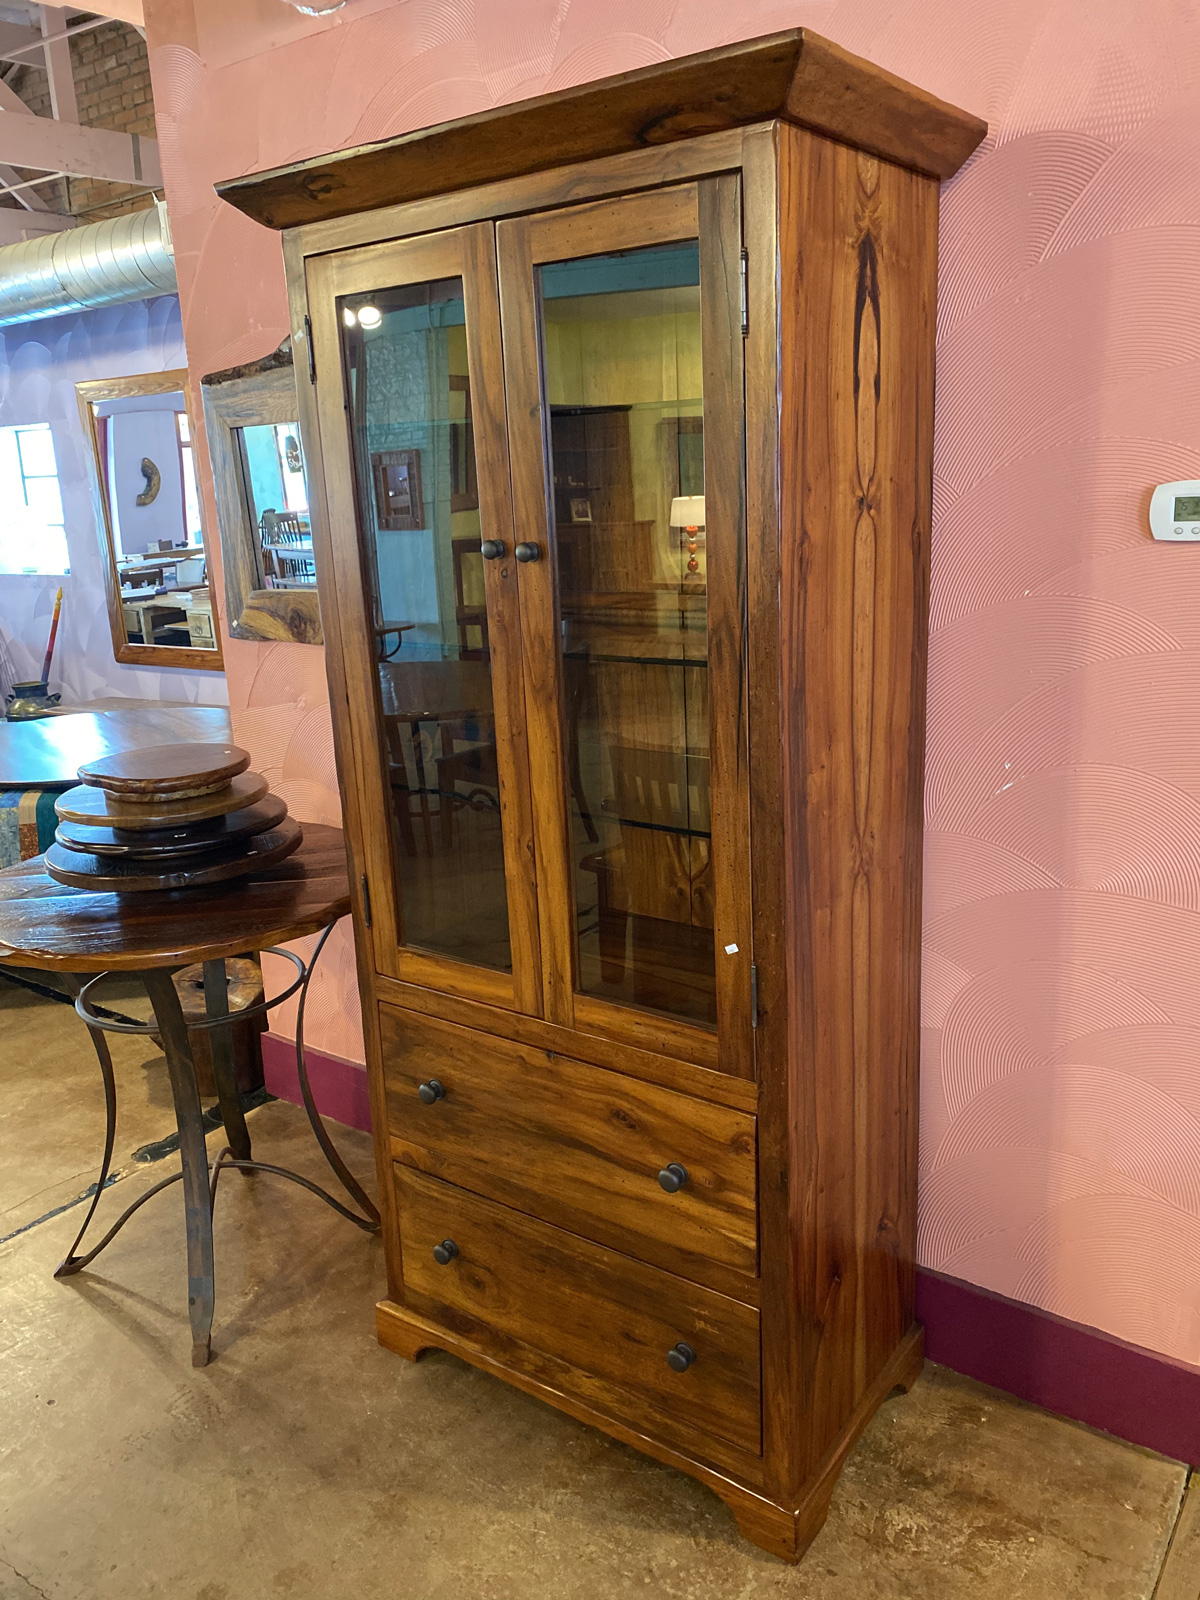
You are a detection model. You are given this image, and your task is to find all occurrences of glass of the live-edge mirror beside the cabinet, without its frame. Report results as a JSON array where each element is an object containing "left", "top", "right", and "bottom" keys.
[{"left": 235, "top": 422, "right": 317, "bottom": 589}]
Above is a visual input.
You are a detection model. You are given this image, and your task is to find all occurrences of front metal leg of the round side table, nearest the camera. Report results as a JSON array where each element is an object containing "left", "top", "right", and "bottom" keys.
[{"left": 139, "top": 968, "right": 216, "bottom": 1366}]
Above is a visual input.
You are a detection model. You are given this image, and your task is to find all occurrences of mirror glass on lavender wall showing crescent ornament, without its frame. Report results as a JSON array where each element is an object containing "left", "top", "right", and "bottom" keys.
[{"left": 91, "top": 390, "right": 216, "bottom": 650}]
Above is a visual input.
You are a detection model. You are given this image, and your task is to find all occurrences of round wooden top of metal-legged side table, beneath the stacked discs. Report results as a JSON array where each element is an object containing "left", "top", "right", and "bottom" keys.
[{"left": 0, "top": 822, "right": 350, "bottom": 973}]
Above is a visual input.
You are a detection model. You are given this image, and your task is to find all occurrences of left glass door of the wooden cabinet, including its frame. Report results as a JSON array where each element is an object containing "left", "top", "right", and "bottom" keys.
[{"left": 305, "top": 227, "right": 539, "bottom": 1011}]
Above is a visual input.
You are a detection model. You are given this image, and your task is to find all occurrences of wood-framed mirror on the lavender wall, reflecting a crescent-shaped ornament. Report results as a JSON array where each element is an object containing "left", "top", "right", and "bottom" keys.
[{"left": 75, "top": 368, "right": 224, "bottom": 672}]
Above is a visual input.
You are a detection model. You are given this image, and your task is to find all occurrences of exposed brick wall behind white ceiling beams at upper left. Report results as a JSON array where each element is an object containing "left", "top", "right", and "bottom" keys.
[{"left": 8, "top": 18, "right": 155, "bottom": 222}]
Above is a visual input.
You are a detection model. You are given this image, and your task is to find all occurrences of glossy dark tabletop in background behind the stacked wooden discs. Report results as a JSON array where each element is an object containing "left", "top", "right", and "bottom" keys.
[{"left": 0, "top": 706, "right": 232, "bottom": 789}]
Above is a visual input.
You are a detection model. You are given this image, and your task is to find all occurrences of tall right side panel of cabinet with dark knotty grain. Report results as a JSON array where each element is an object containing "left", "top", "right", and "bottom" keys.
[{"left": 779, "top": 126, "right": 938, "bottom": 1472}]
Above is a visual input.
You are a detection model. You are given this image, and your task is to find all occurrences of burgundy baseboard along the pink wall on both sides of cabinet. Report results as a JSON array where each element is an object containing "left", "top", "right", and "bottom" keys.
[{"left": 262, "top": 1034, "right": 1200, "bottom": 1466}]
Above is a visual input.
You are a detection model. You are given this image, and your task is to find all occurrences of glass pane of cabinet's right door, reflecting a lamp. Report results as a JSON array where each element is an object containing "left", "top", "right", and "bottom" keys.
[{"left": 541, "top": 242, "right": 717, "bottom": 1026}]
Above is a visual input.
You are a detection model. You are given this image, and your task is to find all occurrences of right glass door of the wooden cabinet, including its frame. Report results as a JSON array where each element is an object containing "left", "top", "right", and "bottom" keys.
[{"left": 499, "top": 186, "right": 750, "bottom": 1070}]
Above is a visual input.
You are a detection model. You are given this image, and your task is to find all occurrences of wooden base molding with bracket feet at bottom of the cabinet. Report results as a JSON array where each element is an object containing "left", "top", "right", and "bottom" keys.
[{"left": 376, "top": 1301, "right": 925, "bottom": 1563}]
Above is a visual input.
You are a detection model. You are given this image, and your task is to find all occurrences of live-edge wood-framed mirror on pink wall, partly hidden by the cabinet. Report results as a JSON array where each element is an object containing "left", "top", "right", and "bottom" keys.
[{"left": 202, "top": 344, "right": 323, "bottom": 645}]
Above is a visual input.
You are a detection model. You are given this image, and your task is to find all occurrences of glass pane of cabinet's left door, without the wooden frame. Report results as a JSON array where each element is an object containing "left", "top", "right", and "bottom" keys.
[{"left": 338, "top": 278, "right": 512, "bottom": 971}]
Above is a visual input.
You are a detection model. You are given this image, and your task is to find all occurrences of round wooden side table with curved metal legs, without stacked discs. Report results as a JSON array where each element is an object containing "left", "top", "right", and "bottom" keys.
[{"left": 0, "top": 824, "right": 379, "bottom": 1366}]
